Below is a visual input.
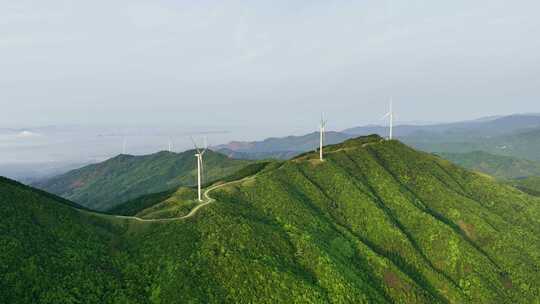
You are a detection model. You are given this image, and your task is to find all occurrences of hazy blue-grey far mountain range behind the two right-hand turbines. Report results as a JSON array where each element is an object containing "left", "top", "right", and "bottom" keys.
[{"left": 213, "top": 114, "right": 540, "bottom": 161}]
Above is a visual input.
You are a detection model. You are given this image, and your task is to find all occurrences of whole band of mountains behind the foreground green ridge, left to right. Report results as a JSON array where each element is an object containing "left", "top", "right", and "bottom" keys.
[{"left": 33, "top": 111, "right": 540, "bottom": 214}]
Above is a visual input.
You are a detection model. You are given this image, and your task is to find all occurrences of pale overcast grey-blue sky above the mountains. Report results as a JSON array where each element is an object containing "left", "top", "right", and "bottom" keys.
[{"left": 0, "top": 0, "right": 540, "bottom": 139}]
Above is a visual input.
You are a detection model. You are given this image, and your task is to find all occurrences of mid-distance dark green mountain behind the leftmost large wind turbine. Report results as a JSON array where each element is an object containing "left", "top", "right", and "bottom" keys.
[{"left": 34, "top": 151, "right": 249, "bottom": 210}]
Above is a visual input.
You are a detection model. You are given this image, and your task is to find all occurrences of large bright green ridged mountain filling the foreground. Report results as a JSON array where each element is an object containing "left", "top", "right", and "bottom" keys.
[{"left": 0, "top": 136, "right": 540, "bottom": 303}]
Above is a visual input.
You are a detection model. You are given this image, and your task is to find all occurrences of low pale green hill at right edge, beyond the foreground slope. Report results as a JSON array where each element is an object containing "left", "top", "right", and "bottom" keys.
[{"left": 437, "top": 151, "right": 540, "bottom": 179}]
